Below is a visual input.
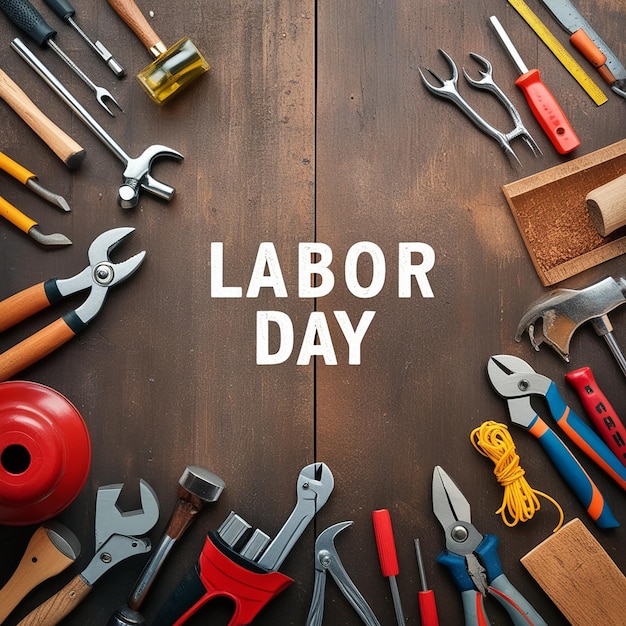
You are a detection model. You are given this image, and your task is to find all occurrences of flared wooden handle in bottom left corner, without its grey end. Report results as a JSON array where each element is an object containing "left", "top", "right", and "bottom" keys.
[{"left": 0, "top": 526, "right": 75, "bottom": 624}]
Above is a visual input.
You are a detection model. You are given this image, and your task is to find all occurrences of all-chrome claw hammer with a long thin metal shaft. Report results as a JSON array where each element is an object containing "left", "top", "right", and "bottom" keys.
[{"left": 11, "top": 38, "right": 183, "bottom": 209}]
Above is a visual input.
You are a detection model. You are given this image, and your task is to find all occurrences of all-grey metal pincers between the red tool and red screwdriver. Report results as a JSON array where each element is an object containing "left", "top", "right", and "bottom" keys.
[{"left": 306, "top": 521, "right": 380, "bottom": 626}]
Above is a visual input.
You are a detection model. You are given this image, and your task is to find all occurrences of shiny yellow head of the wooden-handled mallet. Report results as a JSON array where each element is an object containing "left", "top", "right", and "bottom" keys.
[{"left": 137, "top": 37, "right": 210, "bottom": 104}]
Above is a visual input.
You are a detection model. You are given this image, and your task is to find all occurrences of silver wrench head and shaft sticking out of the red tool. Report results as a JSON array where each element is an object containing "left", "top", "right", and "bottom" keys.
[{"left": 256, "top": 463, "right": 335, "bottom": 571}]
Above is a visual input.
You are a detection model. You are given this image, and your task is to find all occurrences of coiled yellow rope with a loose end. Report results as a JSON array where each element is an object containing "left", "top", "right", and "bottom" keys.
[{"left": 470, "top": 422, "right": 563, "bottom": 532}]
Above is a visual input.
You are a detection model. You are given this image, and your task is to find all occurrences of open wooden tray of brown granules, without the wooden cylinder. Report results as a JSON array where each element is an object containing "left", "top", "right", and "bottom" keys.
[{"left": 502, "top": 139, "right": 626, "bottom": 286}]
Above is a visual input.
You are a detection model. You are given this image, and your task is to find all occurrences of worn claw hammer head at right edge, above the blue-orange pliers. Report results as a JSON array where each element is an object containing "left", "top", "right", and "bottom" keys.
[{"left": 515, "top": 277, "right": 626, "bottom": 361}]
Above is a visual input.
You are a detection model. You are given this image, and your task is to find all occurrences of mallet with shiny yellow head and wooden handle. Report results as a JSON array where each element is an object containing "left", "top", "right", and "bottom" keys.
[{"left": 107, "top": 0, "right": 210, "bottom": 104}]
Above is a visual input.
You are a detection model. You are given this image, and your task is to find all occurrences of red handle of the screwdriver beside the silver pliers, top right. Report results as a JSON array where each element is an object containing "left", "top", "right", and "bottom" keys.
[{"left": 515, "top": 69, "right": 580, "bottom": 154}]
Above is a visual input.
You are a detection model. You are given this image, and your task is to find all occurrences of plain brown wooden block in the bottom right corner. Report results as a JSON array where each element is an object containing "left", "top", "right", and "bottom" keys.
[{"left": 520, "top": 519, "right": 626, "bottom": 626}]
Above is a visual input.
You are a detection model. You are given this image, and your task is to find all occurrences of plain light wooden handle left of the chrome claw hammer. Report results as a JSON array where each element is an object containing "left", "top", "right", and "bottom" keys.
[{"left": 0, "top": 70, "right": 86, "bottom": 169}]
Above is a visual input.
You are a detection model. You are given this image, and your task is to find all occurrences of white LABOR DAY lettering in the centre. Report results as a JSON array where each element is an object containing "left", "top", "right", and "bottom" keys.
[{"left": 211, "top": 241, "right": 435, "bottom": 365}]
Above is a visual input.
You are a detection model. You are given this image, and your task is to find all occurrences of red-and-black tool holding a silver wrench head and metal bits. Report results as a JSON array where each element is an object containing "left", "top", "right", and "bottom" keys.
[{"left": 153, "top": 463, "right": 334, "bottom": 626}]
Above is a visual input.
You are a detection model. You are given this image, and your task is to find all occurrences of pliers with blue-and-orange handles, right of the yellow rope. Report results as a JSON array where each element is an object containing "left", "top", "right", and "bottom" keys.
[{"left": 487, "top": 354, "right": 626, "bottom": 528}]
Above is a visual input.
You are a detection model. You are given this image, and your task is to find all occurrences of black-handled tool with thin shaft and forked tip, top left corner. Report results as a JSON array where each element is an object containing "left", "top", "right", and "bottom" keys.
[{"left": 0, "top": 0, "right": 122, "bottom": 115}]
